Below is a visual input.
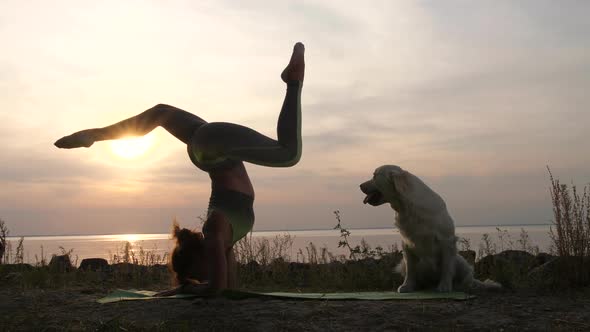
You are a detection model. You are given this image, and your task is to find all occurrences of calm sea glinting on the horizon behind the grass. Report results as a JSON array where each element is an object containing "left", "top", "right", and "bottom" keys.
[{"left": 7, "top": 225, "right": 551, "bottom": 264}]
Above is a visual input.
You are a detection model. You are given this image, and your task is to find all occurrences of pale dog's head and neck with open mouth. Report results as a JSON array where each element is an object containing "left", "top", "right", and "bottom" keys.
[{"left": 360, "top": 165, "right": 446, "bottom": 212}]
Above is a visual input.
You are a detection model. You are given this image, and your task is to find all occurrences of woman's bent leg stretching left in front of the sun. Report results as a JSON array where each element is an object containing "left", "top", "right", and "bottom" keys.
[{"left": 55, "top": 104, "right": 207, "bottom": 149}]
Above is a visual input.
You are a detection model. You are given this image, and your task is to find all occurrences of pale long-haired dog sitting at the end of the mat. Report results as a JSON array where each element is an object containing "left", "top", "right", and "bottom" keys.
[{"left": 360, "top": 165, "right": 499, "bottom": 293}]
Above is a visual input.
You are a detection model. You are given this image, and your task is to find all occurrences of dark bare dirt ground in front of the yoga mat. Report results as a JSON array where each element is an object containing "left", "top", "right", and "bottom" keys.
[{"left": 0, "top": 288, "right": 590, "bottom": 331}]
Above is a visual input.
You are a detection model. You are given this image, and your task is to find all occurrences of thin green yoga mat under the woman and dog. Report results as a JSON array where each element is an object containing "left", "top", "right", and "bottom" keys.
[{"left": 98, "top": 289, "right": 475, "bottom": 303}]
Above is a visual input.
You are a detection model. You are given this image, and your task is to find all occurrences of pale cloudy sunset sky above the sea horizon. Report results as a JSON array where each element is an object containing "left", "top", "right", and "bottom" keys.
[{"left": 0, "top": 0, "right": 590, "bottom": 235}]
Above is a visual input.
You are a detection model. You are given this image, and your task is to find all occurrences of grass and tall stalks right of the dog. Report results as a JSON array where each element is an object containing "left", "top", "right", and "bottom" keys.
[{"left": 476, "top": 167, "right": 590, "bottom": 290}]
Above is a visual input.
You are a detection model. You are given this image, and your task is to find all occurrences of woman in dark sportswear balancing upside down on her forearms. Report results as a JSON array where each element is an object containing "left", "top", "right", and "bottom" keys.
[{"left": 55, "top": 43, "right": 305, "bottom": 296}]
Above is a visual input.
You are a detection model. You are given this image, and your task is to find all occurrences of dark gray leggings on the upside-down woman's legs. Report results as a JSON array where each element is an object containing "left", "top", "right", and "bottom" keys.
[{"left": 85, "top": 81, "right": 302, "bottom": 171}]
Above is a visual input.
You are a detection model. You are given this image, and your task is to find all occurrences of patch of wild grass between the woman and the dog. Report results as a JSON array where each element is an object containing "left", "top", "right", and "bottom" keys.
[{"left": 235, "top": 211, "right": 402, "bottom": 291}]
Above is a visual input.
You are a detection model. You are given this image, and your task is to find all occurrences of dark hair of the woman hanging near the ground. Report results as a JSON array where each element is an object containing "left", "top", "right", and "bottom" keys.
[{"left": 169, "top": 220, "right": 204, "bottom": 284}]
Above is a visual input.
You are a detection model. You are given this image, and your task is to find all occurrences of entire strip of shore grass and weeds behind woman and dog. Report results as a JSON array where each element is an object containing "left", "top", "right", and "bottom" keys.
[{"left": 0, "top": 170, "right": 590, "bottom": 291}]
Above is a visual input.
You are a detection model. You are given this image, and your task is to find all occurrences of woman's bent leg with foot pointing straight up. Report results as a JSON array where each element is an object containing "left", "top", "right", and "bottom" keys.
[{"left": 189, "top": 43, "right": 305, "bottom": 167}]
